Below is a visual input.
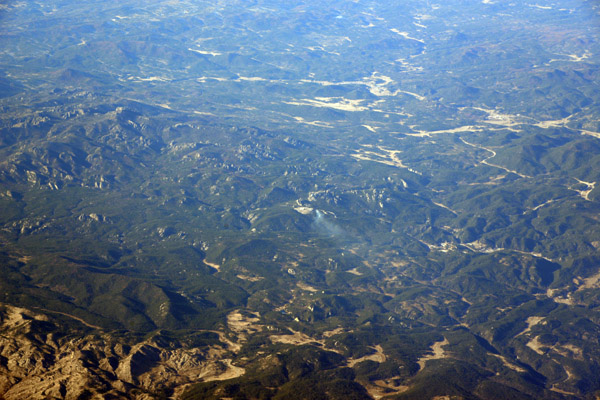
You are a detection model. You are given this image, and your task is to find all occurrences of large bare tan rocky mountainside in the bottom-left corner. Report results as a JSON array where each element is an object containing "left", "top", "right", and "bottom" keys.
[{"left": 0, "top": 306, "right": 239, "bottom": 400}]
